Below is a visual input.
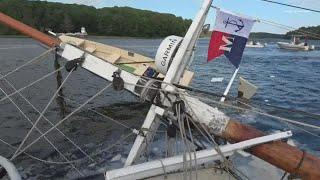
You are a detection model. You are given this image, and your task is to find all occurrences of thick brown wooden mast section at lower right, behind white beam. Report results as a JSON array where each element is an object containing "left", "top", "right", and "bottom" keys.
[{"left": 222, "top": 120, "right": 320, "bottom": 179}]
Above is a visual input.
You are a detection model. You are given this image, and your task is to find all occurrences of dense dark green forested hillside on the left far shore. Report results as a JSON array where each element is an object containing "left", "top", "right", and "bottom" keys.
[{"left": 0, "top": 0, "right": 192, "bottom": 37}]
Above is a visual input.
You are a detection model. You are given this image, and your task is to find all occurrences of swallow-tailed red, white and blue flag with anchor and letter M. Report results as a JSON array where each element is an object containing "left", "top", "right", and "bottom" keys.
[{"left": 208, "top": 10, "right": 255, "bottom": 68}]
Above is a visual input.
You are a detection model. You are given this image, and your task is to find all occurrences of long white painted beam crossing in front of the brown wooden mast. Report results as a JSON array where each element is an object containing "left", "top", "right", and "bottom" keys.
[{"left": 105, "top": 131, "right": 292, "bottom": 180}]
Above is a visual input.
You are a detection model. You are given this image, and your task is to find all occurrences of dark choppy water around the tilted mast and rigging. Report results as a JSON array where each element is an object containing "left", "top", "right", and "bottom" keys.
[{"left": 0, "top": 38, "right": 320, "bottom": 179}]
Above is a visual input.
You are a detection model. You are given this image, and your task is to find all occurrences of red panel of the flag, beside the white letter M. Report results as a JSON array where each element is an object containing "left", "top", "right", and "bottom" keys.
[{"left": 207, "top": 31, "right": 230, "bottom": 62}]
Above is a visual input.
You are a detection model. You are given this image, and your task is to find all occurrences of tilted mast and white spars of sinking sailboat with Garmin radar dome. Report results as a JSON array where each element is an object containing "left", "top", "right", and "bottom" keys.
[{"left": 0, "top": 0, "right": 320, "bottom": 179}]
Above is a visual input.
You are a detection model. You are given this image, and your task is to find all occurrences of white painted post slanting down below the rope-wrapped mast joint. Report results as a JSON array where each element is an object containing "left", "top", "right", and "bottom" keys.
[{"left": 125, "top": 105, "right": 162, "bottom": 166}]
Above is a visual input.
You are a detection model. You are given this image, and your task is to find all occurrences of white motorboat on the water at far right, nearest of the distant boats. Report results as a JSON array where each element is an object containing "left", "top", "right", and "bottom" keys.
[{"left": 277, "top": 36, "right": 315, "bottom": 51}]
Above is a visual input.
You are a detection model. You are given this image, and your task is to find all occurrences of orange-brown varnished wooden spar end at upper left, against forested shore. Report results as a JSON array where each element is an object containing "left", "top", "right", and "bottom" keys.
[{"left": 0, "top": 12, "right": 60, "bottom": 47}]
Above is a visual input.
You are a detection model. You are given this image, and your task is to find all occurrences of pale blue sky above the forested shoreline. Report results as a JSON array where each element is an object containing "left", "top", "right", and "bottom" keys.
[{"left": 46, "top": 0, "right": 320, "bottom": 34}]
